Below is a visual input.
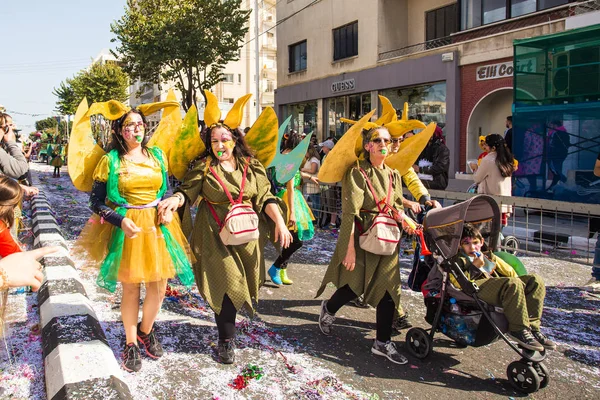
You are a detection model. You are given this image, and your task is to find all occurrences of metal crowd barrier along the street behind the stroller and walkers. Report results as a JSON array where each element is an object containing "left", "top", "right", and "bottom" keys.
[{"left": 303, "top": 183, "right": 600, "bottom": 265}]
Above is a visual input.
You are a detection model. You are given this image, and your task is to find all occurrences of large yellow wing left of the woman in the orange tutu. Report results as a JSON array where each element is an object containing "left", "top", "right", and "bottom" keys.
[{"left": 68, "top": 98, "right": 106, "bottom": 192}]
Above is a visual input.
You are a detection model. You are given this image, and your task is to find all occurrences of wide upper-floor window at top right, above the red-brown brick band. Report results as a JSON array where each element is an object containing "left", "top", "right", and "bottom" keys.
[{"left": 456, "top": 0, "right": 574, "bottom": 32}]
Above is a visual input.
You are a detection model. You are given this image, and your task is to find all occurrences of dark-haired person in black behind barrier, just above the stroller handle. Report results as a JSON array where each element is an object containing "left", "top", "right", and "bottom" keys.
[{"left": 413, "top": 126, "right": 450, "bottom": 190}]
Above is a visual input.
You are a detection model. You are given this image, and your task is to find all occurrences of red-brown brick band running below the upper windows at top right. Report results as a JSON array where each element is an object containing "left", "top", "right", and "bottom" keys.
[{"left": 378, "top": 0, "right": 600, "bottom": 61}]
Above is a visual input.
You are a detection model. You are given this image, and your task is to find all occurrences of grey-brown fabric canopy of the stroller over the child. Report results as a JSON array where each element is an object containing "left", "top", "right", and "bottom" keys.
[{"left": 423, "top": 194, "right": 501, "bottom": 258}]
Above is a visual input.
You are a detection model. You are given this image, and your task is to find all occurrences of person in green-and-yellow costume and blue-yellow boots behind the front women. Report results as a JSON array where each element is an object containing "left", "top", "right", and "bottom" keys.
[{"left": 269, "top": 131, "right": 315, "bottom": 286}]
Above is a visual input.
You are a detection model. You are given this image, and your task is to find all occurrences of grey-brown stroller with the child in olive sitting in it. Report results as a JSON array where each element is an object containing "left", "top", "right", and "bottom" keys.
[{"left": 406, "top": 195, "right": 556, "bottom": 393}]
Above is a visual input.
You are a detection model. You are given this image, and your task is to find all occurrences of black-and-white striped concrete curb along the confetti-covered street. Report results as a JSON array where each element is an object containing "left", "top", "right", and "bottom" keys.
[{"left": 31, "top": 192, "right": 132, "bottom": 400}]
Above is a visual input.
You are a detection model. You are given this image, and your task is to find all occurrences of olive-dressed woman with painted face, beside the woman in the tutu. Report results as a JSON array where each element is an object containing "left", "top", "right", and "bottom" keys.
[{"left": 159, "top": 121, "right": 292, "bottom": 364}]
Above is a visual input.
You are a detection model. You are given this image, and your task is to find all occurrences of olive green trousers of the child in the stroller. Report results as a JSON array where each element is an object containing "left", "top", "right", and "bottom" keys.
[{"left": 475, "top": 275, "right": 546, "bottom": 332}]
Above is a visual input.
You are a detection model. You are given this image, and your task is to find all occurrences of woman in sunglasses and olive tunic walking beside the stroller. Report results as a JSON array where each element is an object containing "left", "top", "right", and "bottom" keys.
[{"left": 317, "top": 127, "right": 414, "bottom": 364}]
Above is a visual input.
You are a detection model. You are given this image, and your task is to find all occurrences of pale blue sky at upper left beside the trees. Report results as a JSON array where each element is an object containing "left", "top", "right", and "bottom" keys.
[{"left": 0, "top": 0, "right": 126, "bottom": 133}]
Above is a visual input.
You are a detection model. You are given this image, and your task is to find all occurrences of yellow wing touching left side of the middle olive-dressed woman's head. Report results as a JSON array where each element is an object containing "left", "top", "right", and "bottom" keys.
[{"left": 169, "top": 105, "right": 206, "bottom": 180}]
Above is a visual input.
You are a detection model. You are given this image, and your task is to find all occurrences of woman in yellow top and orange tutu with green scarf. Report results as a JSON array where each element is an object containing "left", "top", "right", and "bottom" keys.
[{"left": 71, "top": 107, "right": 193, "bottom": 372}]
